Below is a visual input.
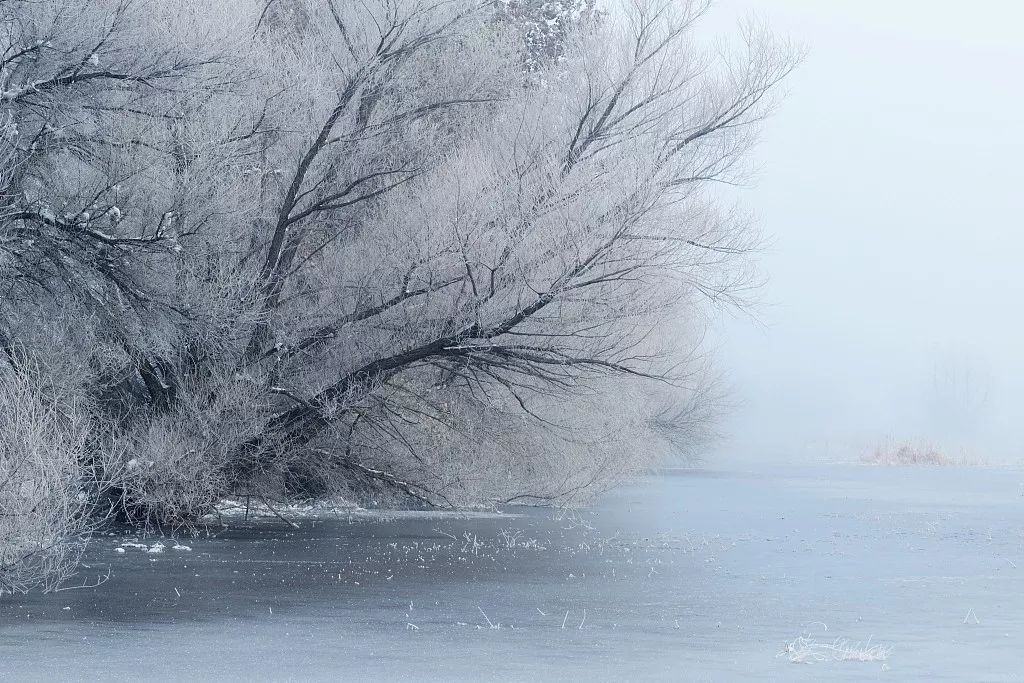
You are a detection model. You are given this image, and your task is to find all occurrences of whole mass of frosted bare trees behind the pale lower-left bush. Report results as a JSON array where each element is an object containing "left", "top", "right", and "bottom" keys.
[{"left": 0, "top": 0, "right": 795, "bottom": 561}]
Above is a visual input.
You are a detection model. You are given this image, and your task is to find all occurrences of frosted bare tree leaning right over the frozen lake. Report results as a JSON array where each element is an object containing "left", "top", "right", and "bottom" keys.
[{"left": 222, "top": 4, "right": 793, "bottom": 507}]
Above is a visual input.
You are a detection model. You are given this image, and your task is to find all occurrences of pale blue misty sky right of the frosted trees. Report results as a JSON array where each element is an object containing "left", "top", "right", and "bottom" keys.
[{"left": 712, "top": 0, "right": 1024, "bottom": 460}]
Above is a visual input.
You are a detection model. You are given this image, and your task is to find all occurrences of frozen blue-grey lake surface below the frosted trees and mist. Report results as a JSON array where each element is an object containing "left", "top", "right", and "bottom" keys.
[{"left": 0, "top": 465, "right": 1024, "bottom": 681}]
